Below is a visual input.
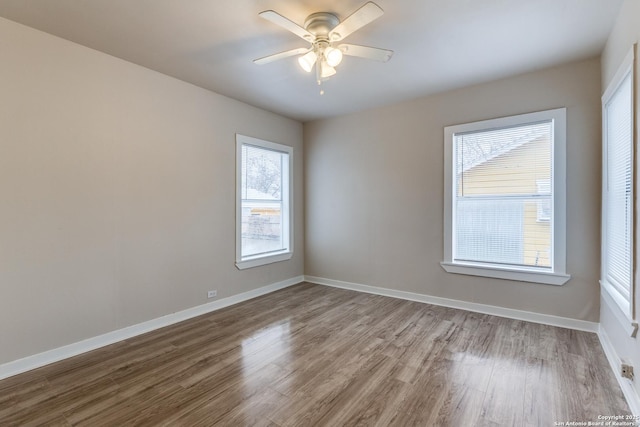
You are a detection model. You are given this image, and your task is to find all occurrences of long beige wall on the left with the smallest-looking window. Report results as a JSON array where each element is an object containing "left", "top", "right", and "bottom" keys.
[{"left": 0, "top": 19, "right": 304, "bottom": 364}]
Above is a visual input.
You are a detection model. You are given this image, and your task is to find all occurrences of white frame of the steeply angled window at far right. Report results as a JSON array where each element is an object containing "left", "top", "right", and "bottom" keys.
[{"left": 600, "top": 45, "right": 638, "bottom": 330}]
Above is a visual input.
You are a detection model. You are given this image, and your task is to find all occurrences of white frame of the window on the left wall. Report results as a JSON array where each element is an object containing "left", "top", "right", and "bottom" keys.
[{"left": 236, "top": 134, "right": 293, "bottom": 270}]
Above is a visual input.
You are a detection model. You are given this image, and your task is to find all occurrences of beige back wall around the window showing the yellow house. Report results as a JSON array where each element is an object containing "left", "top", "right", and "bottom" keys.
[{"left": 304, "top": 58, "right": 601, "bottom": 322}]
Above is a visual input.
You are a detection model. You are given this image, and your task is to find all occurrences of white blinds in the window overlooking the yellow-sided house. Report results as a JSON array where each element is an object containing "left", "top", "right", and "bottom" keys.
[{"left": 453, "top": 120, "right": 553, "bottom": 269}]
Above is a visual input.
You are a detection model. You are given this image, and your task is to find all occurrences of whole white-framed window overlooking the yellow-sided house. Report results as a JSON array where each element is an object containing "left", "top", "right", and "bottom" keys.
[{"left": 441, "top": 108, "right": 570, "bottom": 285}]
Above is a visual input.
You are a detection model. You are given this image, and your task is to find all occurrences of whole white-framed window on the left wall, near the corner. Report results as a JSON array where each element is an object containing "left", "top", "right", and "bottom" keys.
[{"left": 236, "top": 135, "right": 293, "bottom": 269}]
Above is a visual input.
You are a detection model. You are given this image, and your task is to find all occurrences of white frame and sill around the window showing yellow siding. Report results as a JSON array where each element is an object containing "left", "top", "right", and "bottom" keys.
[{"left": 440, "top": 108, "right": 571, "bottom": 285}]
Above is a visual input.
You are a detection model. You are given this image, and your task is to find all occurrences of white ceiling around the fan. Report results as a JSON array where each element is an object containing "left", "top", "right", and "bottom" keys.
[{"left": 0, "top": 0, "right": 623, "bottom": 121}]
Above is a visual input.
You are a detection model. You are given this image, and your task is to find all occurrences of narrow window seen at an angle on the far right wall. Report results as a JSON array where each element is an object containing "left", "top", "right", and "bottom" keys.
[{"left": 600, "top": 45, "right": 634, "bottom": 319}]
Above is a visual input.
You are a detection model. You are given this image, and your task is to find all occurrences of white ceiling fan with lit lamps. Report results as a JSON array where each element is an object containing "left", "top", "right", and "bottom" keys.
[{"left": 253, "top": 2, "right": 393, "bottom": 87}]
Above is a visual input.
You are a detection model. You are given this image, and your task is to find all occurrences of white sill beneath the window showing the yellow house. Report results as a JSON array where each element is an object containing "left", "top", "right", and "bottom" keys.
[{"left": 440, "top": 261, "right": 571, "bottom": 286}]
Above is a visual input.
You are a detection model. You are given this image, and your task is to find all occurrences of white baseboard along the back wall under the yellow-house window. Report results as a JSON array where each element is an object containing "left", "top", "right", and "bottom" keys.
[{"left": 304, "top": 276, "right": 599, "bottom": 333}]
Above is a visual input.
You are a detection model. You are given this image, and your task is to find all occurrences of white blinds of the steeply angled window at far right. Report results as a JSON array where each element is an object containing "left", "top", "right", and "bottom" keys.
[{"left": 603, "top": 74, "right": 633, "bottom": 302}]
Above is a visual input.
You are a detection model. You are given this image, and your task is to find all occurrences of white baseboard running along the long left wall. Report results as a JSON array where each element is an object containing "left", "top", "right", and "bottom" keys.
[{"left": 0, "top": 276, "right": 304, "bottom": 380}]
